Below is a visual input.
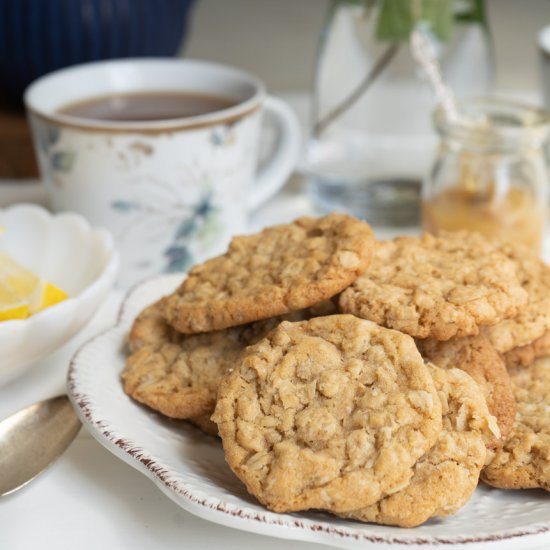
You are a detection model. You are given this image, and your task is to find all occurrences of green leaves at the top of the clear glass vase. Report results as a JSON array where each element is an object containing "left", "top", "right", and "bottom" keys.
[{"left": 376, "top": 0, "right": 453, "bottom": 42}]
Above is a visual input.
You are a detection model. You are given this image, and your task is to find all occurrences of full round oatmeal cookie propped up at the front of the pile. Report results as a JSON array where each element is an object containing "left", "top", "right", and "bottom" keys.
[{"left": 212, "top": 315, "right": 442, "bottom": 512}]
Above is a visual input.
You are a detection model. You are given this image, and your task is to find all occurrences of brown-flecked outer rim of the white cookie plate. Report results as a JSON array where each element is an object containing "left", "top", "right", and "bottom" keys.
[{"left": 66, "top": 273, "right": 550, "bottom": 548}]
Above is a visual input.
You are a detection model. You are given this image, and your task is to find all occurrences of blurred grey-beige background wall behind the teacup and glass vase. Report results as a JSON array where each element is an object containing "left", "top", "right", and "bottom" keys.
[{"left": 184, "top": 0, "right": 550, "bottom": 91}]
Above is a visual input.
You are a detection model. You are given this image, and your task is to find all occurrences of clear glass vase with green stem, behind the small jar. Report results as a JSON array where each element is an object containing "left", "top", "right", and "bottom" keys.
[{"left": 304, "top": 0, "right": 494, "bottom": 225}]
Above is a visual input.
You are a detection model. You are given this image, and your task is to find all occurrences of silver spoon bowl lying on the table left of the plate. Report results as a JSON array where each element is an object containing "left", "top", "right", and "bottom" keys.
[{"left": 0, "top": 395, "right": 81, "bottom": 496}]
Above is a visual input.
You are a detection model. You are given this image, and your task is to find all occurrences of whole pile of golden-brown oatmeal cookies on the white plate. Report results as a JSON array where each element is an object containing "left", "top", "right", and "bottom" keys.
[{"left": 122, "top": 214, "right": 550, "bottom": 527}]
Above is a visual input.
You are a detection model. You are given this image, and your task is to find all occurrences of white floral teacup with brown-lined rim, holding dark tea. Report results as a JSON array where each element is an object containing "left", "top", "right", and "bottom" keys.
[{"left": 25, "top": 59, "right": 301, "bottom": 287}]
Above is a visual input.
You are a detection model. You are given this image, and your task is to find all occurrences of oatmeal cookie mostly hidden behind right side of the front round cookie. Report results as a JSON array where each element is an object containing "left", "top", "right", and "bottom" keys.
[{"left": 344, "top": 366, "right": 498, "bottom": 527}]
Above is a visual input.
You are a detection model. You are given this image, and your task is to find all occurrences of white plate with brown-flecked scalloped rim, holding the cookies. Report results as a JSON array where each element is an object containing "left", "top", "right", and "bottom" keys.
[{"left": 67, "top": 275, "right": 550, "bottom": 550}]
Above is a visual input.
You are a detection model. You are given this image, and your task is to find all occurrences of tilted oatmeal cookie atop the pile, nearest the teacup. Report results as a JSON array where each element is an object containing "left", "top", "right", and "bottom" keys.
[{"left": 163, "top": 214, "right": 374, "bottom": 334}]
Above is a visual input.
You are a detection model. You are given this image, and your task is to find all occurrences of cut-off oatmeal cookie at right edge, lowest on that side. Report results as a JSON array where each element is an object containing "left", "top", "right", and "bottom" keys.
[{"left": 481, "top": 358, "right": 550, "bottom": 491}]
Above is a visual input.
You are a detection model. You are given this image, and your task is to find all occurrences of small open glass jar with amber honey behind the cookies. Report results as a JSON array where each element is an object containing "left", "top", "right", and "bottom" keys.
[{"left": 422, "top": 99, "right": 550, "bottom": 252}]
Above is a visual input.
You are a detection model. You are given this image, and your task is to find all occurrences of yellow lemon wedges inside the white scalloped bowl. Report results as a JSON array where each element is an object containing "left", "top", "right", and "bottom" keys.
[{"left": 0, "top": 253, "right": 67, "bottom": 321}]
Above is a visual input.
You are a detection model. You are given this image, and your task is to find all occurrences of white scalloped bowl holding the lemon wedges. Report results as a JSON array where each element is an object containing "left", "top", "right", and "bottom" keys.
[{"left": 0, "top": 204, "right": 119, "bottom": 386}]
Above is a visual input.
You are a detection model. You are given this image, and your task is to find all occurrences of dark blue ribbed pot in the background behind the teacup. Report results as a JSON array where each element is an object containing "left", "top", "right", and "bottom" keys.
[{"left": 0, "top": 0, "right": 193, "bottom": 102}]
